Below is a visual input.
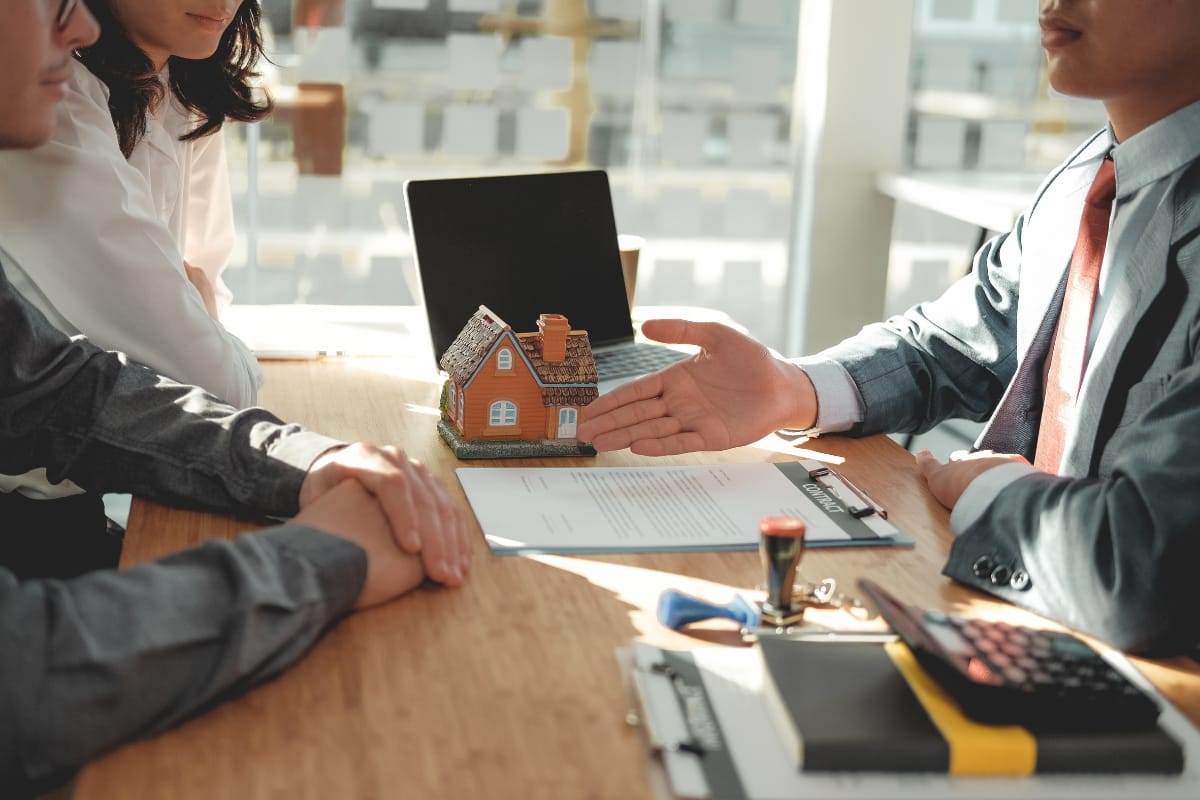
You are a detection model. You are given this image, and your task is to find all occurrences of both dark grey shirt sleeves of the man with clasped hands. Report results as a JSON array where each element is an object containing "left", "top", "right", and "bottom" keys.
[{"left": 0, "top": 261, "right": 366, "bottom": 796}]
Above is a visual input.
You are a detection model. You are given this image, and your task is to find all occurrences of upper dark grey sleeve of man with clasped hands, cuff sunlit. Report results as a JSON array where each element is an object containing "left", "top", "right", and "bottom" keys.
[{"left": 0, "top": 260, "right": 338, "bottom": 516}]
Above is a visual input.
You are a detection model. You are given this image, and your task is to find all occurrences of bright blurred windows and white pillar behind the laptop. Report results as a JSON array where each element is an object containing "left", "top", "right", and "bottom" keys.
[{"left": 226, "top": 0, "right": 1104, "bottom": 453}]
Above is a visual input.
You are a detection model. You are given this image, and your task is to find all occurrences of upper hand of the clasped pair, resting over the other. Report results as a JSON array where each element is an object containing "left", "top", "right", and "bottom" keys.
[{"left": 300, "top": 443, "right": 472, "bottom": 587}]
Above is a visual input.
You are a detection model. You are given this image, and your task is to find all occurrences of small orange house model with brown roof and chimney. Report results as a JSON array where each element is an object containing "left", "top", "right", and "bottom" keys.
[{"left": 438, "top": 306, "right": 599, "bottom": 458}]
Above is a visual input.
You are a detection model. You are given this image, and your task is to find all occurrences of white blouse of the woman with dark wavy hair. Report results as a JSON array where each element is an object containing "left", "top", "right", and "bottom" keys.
[{"left": 0, "top": 62, "right": 263, "bottom": 407}]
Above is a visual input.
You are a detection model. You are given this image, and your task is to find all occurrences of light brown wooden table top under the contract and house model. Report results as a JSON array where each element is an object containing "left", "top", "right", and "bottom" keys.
[{"left": 74, "top": 359, "right": 1200, "bottom": 800}]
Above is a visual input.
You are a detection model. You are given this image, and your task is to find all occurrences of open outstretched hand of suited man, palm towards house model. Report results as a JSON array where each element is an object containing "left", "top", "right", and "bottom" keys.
[{"left": 577, "top": 319, "right": 816, "bottom": 456}]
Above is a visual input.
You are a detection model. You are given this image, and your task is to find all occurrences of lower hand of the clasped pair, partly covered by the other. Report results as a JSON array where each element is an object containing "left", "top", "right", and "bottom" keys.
[{"left": 295, "top": 480, "right": 425, "bottom": 608}]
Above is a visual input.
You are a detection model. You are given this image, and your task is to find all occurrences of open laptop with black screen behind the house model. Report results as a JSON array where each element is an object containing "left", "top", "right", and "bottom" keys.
[{"left": 404, "top": 170, "right": 688, "bottom": 392}]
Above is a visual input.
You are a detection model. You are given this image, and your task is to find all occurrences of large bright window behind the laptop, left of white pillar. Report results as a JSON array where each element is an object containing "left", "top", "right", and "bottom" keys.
[{"left": 224, "top": 0, "right": 799, "bottom": 344}]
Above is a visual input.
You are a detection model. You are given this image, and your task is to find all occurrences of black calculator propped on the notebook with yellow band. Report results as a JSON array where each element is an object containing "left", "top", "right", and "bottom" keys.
[{"left": 859, "top": 578, "right": 1159, "bottom": 733}]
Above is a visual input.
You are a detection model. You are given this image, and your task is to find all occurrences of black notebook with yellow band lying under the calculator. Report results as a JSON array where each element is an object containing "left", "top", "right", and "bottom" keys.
[{"left": 757, "top": 638, "right": 1183, "bottom": 775}]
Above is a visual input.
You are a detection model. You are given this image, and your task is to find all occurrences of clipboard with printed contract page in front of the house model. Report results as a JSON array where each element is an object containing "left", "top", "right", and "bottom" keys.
[{"left": 457, "top": 462, "right": 912, "bottom": 554}]
